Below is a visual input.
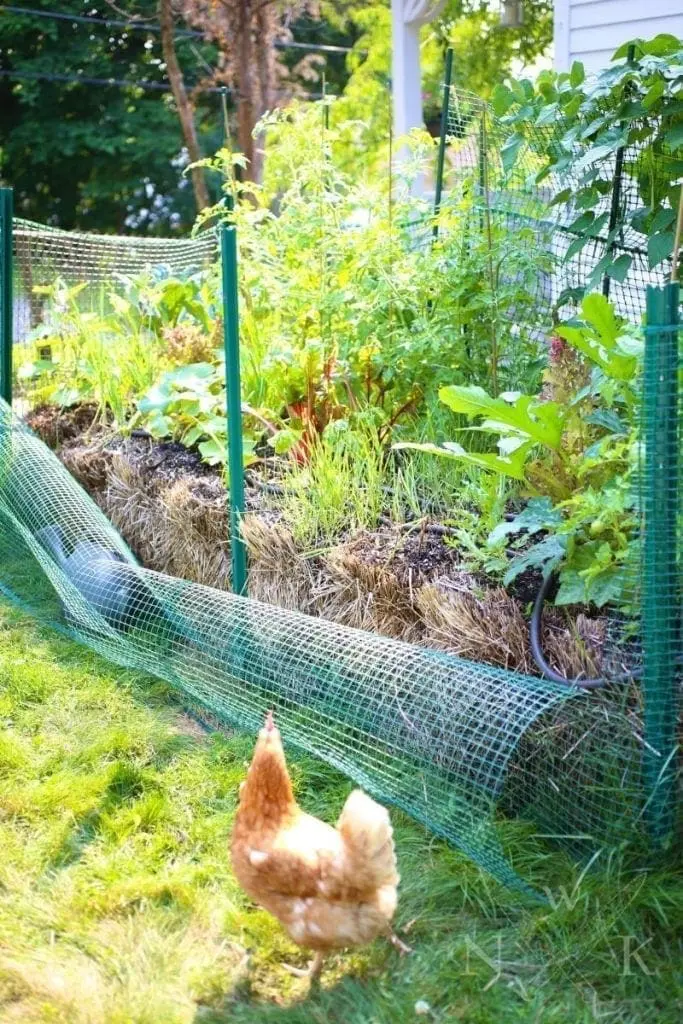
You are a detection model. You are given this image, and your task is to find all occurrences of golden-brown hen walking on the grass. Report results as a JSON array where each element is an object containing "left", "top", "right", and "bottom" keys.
[{"left": 230, "top": 712, "right": 410, "bottom": 978}]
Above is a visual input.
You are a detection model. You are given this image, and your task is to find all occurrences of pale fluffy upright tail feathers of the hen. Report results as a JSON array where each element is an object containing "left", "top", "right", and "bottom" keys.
[{"left": 337, "top": 790, "right": 398, "bottom": 889}]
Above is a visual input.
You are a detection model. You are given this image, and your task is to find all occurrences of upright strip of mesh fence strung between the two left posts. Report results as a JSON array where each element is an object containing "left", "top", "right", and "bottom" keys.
[{"left": 13, "top": 218, "right": 218, "bottom": 342}]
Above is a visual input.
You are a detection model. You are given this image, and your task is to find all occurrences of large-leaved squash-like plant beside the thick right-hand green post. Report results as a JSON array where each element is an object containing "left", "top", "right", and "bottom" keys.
[{"left": 397, "top": 295, "right": 642, "bottom": 605}]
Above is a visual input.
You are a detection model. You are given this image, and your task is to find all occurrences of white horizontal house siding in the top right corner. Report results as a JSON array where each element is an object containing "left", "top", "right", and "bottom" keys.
[{"left": 555, "top": 0, "right": 683, "bottom": 74}]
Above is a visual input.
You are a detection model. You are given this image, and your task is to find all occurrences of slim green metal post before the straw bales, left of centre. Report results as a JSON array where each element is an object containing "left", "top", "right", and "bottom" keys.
[{"left": 220, "top": 196, "right": 247, "bottom": 594}]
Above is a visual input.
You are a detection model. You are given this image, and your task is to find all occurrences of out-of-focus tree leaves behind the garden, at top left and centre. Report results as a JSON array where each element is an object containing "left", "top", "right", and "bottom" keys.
[{"left": 0, "top": 0, "right": 552, "bottom": 234}]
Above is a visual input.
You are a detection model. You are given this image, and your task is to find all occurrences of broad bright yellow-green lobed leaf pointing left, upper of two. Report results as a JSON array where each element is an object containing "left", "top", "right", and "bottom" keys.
[{"left": 438, "top": 384, "right": 565, "bottom": 451}]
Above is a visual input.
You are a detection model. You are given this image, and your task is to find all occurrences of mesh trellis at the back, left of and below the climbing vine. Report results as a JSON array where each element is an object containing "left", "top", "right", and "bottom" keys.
[{"left": 444, "top": 86, "right": 673, "bottom": 327}]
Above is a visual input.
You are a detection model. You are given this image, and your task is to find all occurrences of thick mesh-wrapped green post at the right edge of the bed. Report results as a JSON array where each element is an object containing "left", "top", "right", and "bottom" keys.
[{"left": 641, "top": 284, "right": 681, "bottom": 844}]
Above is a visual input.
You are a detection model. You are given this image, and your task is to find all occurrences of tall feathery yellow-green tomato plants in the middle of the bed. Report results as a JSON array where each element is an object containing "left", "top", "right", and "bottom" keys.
[{"left": 192, "top": 105, "right": 548, "bottom": 437}]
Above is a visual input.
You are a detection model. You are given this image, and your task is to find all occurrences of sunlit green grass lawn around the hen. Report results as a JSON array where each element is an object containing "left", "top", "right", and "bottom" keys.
[{"left": 0, "top": 599, "right": 683, "bottom": 1024}]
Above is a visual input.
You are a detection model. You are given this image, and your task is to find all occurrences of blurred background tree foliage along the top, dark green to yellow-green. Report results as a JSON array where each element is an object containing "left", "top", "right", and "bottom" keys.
[{"left": 0, "top": 0, "right": 552, "bottom": 234}]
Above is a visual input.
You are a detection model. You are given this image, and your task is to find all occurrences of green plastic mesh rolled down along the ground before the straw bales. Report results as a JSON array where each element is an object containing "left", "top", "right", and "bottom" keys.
[{"left": 0, "top": 403, "right": 655, "bottom": 894}]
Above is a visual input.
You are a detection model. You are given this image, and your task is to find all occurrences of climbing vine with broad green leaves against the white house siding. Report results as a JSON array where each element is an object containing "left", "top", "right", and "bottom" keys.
[{"left": 493, "top": 35, "right": 683, "bottom": 290}]
